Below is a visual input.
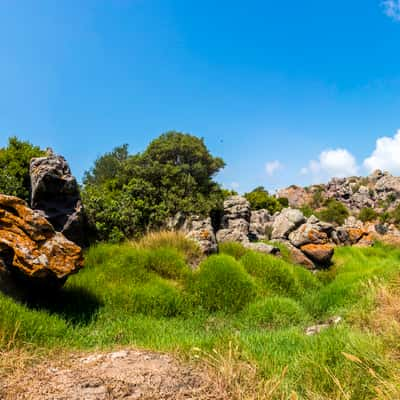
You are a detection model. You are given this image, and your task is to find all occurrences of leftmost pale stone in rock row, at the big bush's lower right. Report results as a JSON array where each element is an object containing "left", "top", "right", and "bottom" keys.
[{"left": 180, "top": 216, "right": 218, "bottom": 255}]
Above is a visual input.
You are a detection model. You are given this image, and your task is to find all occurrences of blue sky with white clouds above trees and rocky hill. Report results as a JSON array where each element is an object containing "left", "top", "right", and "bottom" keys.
[{"left": 0, "top": 0, "right": 400, "bottom": 192}]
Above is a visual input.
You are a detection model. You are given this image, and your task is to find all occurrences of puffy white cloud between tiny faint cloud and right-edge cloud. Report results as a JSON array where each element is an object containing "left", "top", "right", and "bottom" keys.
[{"left": 300, "top": 149, "right": 358, "bottom": 180}]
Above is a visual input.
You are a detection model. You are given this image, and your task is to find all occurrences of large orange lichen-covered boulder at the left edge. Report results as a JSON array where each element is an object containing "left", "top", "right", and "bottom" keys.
[{"left": 0, "top": 194, "right": 83, "bottom": 286}]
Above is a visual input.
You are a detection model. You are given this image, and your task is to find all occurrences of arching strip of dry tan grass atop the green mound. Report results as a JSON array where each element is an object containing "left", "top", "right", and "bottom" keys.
[{"left": 131, "top": 231, "right": 203, "bottom": 266}]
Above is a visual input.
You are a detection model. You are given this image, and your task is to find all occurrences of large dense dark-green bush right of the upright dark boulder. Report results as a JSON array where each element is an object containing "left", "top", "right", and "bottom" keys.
[{"left": 82, "top": 132, "right": 224, "bottom": 241}]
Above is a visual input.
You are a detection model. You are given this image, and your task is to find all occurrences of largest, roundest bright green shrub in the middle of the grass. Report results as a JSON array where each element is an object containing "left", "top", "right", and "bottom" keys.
[{"left": 191, "top": 255, "right": 256, "bottom": 312}]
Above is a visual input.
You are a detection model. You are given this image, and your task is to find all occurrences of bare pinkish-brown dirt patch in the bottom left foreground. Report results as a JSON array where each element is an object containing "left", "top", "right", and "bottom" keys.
[{"left": 0, "top": 349, "right": 226, "bottom": 400}]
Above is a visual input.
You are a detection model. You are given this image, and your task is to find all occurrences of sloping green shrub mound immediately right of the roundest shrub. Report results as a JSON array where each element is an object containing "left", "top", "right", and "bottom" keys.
[{"left": 241, "top": 252, "right": 302, "bottom": 297}]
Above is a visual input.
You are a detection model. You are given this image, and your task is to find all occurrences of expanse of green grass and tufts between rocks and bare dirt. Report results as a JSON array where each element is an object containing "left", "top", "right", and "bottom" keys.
[{"left": 0, "top": 240, "right": 400, "bottom": 399}]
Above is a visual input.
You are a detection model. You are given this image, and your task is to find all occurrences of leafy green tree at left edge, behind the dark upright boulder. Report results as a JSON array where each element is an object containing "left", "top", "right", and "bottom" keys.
[{"left": 0, "top": 136, "right": 44, "bottom": 202}]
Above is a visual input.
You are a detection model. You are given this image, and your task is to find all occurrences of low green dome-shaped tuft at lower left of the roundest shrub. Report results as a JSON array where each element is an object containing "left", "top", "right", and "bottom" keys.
[{"left": 126, "top": 280, "right": 188, "bottom": 317}]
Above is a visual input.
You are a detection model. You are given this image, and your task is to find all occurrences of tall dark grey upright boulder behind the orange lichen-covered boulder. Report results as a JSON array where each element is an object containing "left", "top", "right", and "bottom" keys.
[{"left": 30, "top": 151, "right": 88, "bottom": 247}]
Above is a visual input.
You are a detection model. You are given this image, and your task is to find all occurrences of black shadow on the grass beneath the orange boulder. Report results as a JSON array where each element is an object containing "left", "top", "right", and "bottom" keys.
[{"left": 0, "top": 275, "right": 103, "bottom": 325}]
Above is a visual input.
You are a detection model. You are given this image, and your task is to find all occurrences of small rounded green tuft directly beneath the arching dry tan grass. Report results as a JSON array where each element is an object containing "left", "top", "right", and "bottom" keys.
[{"left": 145, "top": 247, "right": 189, "bottom": 279}]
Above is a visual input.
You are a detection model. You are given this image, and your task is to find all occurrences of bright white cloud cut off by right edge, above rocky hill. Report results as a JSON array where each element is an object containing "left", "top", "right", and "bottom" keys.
[{"left": 364, "top": 130, "right": 400, "bottom": 175}]
